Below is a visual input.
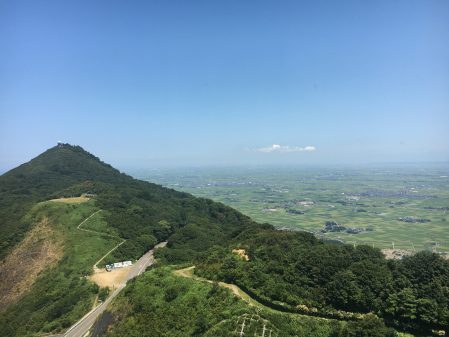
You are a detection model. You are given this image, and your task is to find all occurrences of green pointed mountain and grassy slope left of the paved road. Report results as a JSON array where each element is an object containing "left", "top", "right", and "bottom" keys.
[{"left": 0, "top": 144, "right": 258, "bottom": 336}]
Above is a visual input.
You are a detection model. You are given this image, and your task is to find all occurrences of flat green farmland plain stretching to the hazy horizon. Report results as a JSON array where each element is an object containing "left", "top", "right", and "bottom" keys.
[{"left": 135, "top": 164, "right": 449, "bottom": 253}]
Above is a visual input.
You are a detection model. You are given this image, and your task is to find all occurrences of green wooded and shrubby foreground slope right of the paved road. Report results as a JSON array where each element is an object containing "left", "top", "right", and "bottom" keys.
[{"left": 97, "top": 226, "right": 449, "bottom": 337}]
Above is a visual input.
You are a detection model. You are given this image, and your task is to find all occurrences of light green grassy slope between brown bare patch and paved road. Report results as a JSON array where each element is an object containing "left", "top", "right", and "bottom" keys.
[{"left": 0, "top": 201, "right": 118, "bottom": 336}]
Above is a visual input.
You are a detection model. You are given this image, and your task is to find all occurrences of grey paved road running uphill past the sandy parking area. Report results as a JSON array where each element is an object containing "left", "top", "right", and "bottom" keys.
[{"left": 63, "top": 242, "right": 167, "bottom": 337}]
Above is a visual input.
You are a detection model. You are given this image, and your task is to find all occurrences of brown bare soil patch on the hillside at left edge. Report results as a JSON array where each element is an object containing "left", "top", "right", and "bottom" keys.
[{"left": 0, "top": 218, "right": 63, "bottom": 311}]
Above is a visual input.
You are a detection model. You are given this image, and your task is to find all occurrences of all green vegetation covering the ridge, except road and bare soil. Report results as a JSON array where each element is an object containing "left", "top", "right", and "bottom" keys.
[{"left": 0, "top": 144, "right": 449, "bottom": 337}]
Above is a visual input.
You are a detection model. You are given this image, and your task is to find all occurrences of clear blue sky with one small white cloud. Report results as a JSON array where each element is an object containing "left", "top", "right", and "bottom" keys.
[{"left": 0, "top": 0, "right": 449, "bottom": 170}]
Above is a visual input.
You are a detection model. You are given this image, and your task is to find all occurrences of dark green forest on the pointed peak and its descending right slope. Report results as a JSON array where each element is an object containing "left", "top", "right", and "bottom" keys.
[{"left": 0, "top": 144, "right": 260, "bottom": 258}]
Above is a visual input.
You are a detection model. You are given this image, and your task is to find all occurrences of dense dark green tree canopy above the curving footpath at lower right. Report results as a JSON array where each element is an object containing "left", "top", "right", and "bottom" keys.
[{"left": 196, "top": 230, "right": 449, "bottom": 332}]
